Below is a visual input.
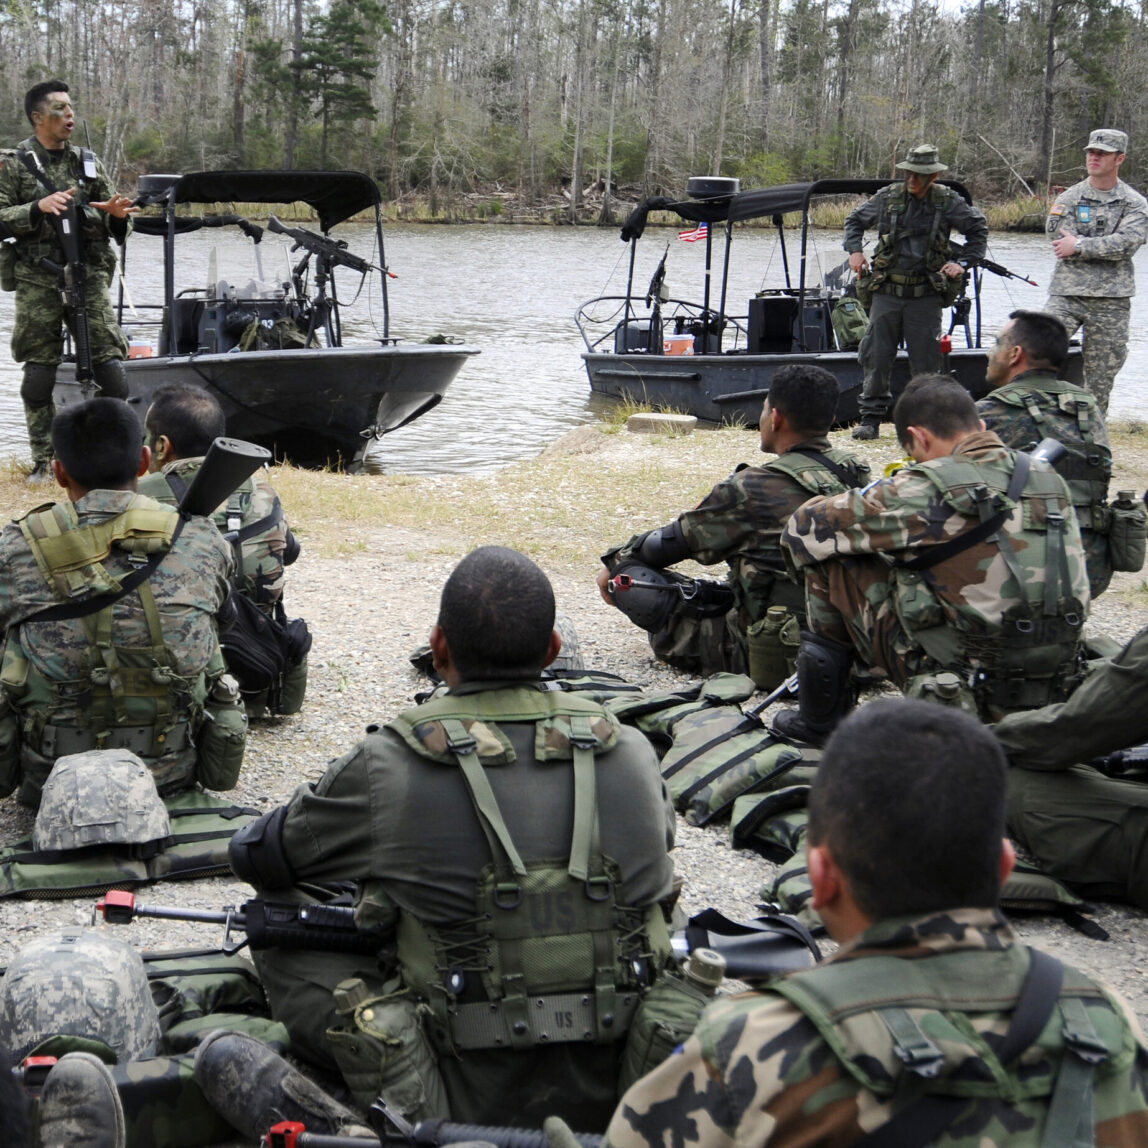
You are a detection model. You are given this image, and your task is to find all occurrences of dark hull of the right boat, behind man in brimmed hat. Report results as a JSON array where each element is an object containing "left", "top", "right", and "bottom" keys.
[{"left": 582, "top": 346, "right": 1081, "bottom": 426}]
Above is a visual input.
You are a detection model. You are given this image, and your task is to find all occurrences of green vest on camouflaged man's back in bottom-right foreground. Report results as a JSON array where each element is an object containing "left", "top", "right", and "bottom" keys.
[{"left": 770, "top": 945, "right": 1135, "bottom": 1145}]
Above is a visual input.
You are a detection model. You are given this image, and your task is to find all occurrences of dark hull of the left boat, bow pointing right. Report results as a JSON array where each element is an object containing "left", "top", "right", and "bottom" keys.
[{"left": 54, "top": 343, "right": 479, "bottom": 470}]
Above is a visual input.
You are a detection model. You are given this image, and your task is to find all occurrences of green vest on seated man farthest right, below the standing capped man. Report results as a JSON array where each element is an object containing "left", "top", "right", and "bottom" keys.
[{"left": 992, "top": 377, "right": 1112, "bottom": 534}]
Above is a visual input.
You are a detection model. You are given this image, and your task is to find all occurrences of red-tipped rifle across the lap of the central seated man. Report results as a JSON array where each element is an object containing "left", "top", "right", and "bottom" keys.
[{"left": 92, "top": 889, "right": 821, "bottom": 982}]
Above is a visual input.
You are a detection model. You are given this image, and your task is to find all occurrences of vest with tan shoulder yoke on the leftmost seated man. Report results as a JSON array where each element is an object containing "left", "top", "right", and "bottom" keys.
[{"left": 0, "top": 496, "right": 211, "bottom": 798}]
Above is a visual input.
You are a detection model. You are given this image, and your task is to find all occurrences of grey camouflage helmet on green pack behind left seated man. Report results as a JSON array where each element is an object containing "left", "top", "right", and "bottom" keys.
[{"left": 32, "top": 750, "right": 171, "bottom": 850}]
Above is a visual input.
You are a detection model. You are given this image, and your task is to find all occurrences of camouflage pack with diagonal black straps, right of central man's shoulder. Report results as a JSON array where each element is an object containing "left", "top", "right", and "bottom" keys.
[{"left": 661, "top": 706, "right": 821, "bottom": 825}]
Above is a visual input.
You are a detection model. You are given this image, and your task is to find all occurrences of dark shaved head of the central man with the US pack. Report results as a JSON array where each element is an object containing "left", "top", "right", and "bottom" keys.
[{"left": 439, "top": 546, "right": 554, "bottom": 682}]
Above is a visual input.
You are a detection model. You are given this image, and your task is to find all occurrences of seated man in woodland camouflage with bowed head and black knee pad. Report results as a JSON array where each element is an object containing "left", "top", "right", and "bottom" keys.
[{"left": 775, "top": 375, "right": 1088, "bottom": 742}]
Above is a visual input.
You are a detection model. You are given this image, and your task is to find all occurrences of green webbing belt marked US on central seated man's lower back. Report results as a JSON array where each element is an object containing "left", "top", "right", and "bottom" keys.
[{"left": 448, "top": 992, "right": 641, "bottom": 1050}]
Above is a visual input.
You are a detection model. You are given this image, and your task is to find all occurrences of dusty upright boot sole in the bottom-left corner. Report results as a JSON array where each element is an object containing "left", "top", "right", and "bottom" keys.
[{"left": 37, "top": 1053, "right": 127, "bottom": 1148}]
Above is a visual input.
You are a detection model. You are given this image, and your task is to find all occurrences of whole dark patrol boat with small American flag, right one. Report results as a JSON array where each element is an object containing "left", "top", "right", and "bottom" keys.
[{"left": 574, "top": 177, "right": 1081, "bottom": 426}]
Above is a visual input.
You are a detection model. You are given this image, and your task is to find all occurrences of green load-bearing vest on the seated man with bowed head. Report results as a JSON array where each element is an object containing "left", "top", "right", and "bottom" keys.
[{"left": 894, "top": 455, "right": 1085, "bottom": 716}]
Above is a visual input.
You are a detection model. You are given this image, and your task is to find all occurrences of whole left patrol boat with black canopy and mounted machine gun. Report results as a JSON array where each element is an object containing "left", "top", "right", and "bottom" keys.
[{"left": 55, "top": 171, "right": 479, "bottom": 472}]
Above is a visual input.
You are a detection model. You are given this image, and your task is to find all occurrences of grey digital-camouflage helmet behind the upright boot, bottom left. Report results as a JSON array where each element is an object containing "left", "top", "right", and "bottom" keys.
[{"left": 0, "top": 929, "right": 160, "bottom": 1064}]
